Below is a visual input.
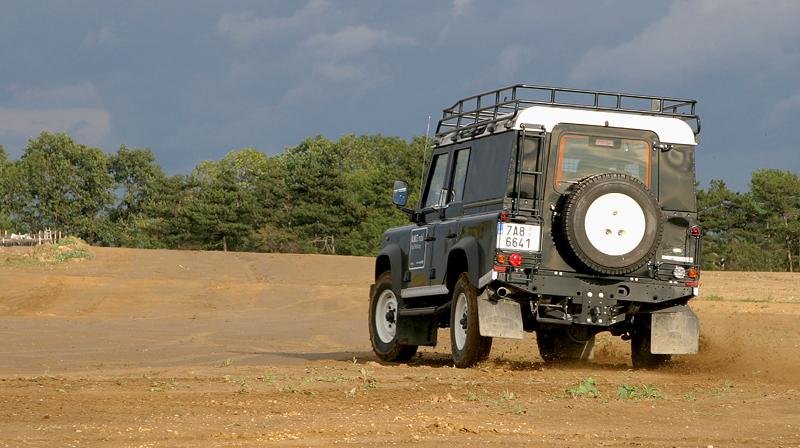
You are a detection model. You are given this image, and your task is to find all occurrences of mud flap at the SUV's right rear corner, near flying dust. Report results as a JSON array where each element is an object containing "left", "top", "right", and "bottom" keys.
[{"left": 650, "top": 306, "right": 700, "bottom": 355}]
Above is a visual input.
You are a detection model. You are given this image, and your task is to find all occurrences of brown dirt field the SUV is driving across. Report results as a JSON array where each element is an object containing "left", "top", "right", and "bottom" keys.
[{"left": 0, "top": 248, "right": 800, "bottom": 447}]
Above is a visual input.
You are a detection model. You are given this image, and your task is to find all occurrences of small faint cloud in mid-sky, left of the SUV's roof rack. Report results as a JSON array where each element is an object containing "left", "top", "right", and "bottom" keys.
[{"left": 306, "top": 25, "right": 414, "bottom": 59}]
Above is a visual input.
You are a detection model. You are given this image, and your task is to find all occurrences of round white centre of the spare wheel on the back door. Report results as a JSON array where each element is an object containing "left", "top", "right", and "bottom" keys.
[{"left": 584, "top": 193, "right": 647, "bottom": 256}]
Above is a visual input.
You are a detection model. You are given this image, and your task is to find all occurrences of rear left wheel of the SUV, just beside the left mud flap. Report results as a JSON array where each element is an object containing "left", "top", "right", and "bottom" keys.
[{"left": 450, "top": 273, "right": 492, "bottom": 368}]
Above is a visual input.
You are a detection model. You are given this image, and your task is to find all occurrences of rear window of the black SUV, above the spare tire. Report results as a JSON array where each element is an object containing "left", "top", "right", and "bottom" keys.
[{"left": 555, "top": 134, "right": 650, "bottom": 191}]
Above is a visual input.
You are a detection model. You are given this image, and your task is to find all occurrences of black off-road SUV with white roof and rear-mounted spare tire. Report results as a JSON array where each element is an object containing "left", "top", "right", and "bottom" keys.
[{"left": 369, "top": 85, "right": 702, "bottom": 367}]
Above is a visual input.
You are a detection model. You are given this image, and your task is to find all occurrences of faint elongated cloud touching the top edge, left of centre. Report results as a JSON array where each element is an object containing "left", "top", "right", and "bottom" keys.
[{"left": 217, "top": 0, "right": 328, "bottom": 45}]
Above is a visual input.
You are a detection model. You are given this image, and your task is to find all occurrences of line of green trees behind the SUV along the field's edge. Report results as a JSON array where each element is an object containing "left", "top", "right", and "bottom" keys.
[{"left": 0, "top": 132, "right": 800, "bottom": 271}]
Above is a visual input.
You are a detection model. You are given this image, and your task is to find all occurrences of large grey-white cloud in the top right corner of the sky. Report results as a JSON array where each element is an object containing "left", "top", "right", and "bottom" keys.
[{"left": 570, "top": 0, "right": 800, "bottom": 83}]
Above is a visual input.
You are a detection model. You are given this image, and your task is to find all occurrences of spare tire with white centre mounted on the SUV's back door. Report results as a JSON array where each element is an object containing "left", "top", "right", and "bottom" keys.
[{"left": 561, "top": 173, "right": 664, "bottom": 275}]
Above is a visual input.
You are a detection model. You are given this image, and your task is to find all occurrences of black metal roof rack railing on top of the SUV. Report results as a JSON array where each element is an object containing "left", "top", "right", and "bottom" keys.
[{"left": 436, "top": 84, "right": 700, "bottom": 137}]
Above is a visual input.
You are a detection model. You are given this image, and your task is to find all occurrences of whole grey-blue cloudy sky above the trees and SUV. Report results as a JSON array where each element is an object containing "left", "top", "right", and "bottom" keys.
[{"left": 0, "top": 0, "right": 800, "bottom": 190}]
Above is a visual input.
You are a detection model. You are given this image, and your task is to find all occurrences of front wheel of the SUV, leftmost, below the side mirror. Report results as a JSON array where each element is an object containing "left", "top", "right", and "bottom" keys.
[{"left": 369, "top": 272, "right": 417, "bottom": 362}]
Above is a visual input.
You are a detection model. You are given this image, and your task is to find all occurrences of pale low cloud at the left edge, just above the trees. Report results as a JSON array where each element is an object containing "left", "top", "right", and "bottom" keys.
[{"left": 0, "top": 107, "right": 111, "bottom": 145}]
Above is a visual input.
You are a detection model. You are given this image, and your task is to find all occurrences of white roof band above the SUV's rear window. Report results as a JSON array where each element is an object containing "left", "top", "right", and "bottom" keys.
[{"left": 514, "top": 106, "right": 697, "bottom": 145}]
